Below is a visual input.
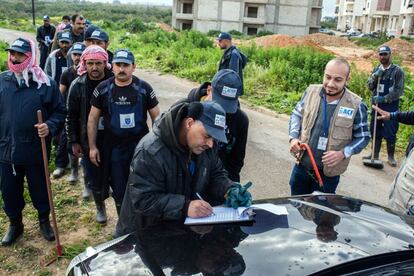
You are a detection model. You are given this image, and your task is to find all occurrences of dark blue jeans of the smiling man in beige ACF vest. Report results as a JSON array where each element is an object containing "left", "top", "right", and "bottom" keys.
[{"left": 289, "top": 164, "right": 339, "bottom": 195}]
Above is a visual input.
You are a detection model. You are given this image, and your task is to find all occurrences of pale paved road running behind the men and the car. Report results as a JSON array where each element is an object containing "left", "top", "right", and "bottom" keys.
[{"left": 0, "top": 29, "right": 397, "bottom": 205}]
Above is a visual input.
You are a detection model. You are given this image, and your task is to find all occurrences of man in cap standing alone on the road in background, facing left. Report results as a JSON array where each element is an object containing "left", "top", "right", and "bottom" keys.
[{"left": 216, "top": 32, "right": 247, "bottom": 96}]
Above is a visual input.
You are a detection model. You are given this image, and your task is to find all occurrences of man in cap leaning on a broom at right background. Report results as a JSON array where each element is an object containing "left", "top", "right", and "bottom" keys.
[{"left": 364, "top": 45, "right": 404, "bottom": 167}]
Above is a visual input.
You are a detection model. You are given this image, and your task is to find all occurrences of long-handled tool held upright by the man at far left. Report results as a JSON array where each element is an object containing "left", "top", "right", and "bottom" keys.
[{"left": 37, "top": 110, "right": 62, "bottom": 265}]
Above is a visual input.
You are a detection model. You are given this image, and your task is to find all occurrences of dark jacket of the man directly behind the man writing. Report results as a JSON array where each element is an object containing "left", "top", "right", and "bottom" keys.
[{"left": 187, "top": 85, "right": 249, "bottom": 182}]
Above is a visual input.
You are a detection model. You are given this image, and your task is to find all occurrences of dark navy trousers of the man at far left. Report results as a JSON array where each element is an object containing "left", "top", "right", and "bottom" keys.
[{"left": 0, "top": 163, "right": 50, "bottom": 219}]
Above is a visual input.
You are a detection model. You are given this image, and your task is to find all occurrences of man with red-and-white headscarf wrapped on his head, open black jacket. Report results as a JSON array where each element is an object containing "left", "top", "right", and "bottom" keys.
[{"left": 66, "top": 45, "right": 113, "bottom": 223}]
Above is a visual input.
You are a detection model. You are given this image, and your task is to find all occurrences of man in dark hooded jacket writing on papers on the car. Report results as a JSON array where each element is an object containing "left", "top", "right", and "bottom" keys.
[{"left": 114, "top": 101, "right": 251, "bottom": 236}]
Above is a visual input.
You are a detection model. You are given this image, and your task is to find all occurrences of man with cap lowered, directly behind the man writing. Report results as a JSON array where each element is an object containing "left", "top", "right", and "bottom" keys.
[{"left": 187, "top": 69, "right": 249, "bottom": 182}]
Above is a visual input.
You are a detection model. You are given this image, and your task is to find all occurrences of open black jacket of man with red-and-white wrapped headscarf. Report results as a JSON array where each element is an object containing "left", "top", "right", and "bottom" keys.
[{"left": 66, "top": 70, "right": 113, "bottom": 153}]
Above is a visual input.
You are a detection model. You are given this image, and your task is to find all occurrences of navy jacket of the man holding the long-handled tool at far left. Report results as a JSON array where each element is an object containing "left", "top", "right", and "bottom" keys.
[{"left": 0, "top": 71, "right": 66, "bottom": 165}]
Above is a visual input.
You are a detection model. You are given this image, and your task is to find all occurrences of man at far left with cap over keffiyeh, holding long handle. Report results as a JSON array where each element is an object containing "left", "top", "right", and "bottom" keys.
[{"left": 0, "top": 38, "right": 66, "bottom": 246}]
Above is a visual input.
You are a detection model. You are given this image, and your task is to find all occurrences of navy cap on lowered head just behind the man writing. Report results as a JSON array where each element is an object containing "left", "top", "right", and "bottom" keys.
[{"left": 211, "top": 69, "right": 242, "bottom": 114}]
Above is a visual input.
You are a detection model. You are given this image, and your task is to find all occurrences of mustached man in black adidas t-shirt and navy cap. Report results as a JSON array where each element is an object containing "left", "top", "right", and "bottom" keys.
[{"left": 88, "top": 49, "right": 160, "bottom": 215}]
